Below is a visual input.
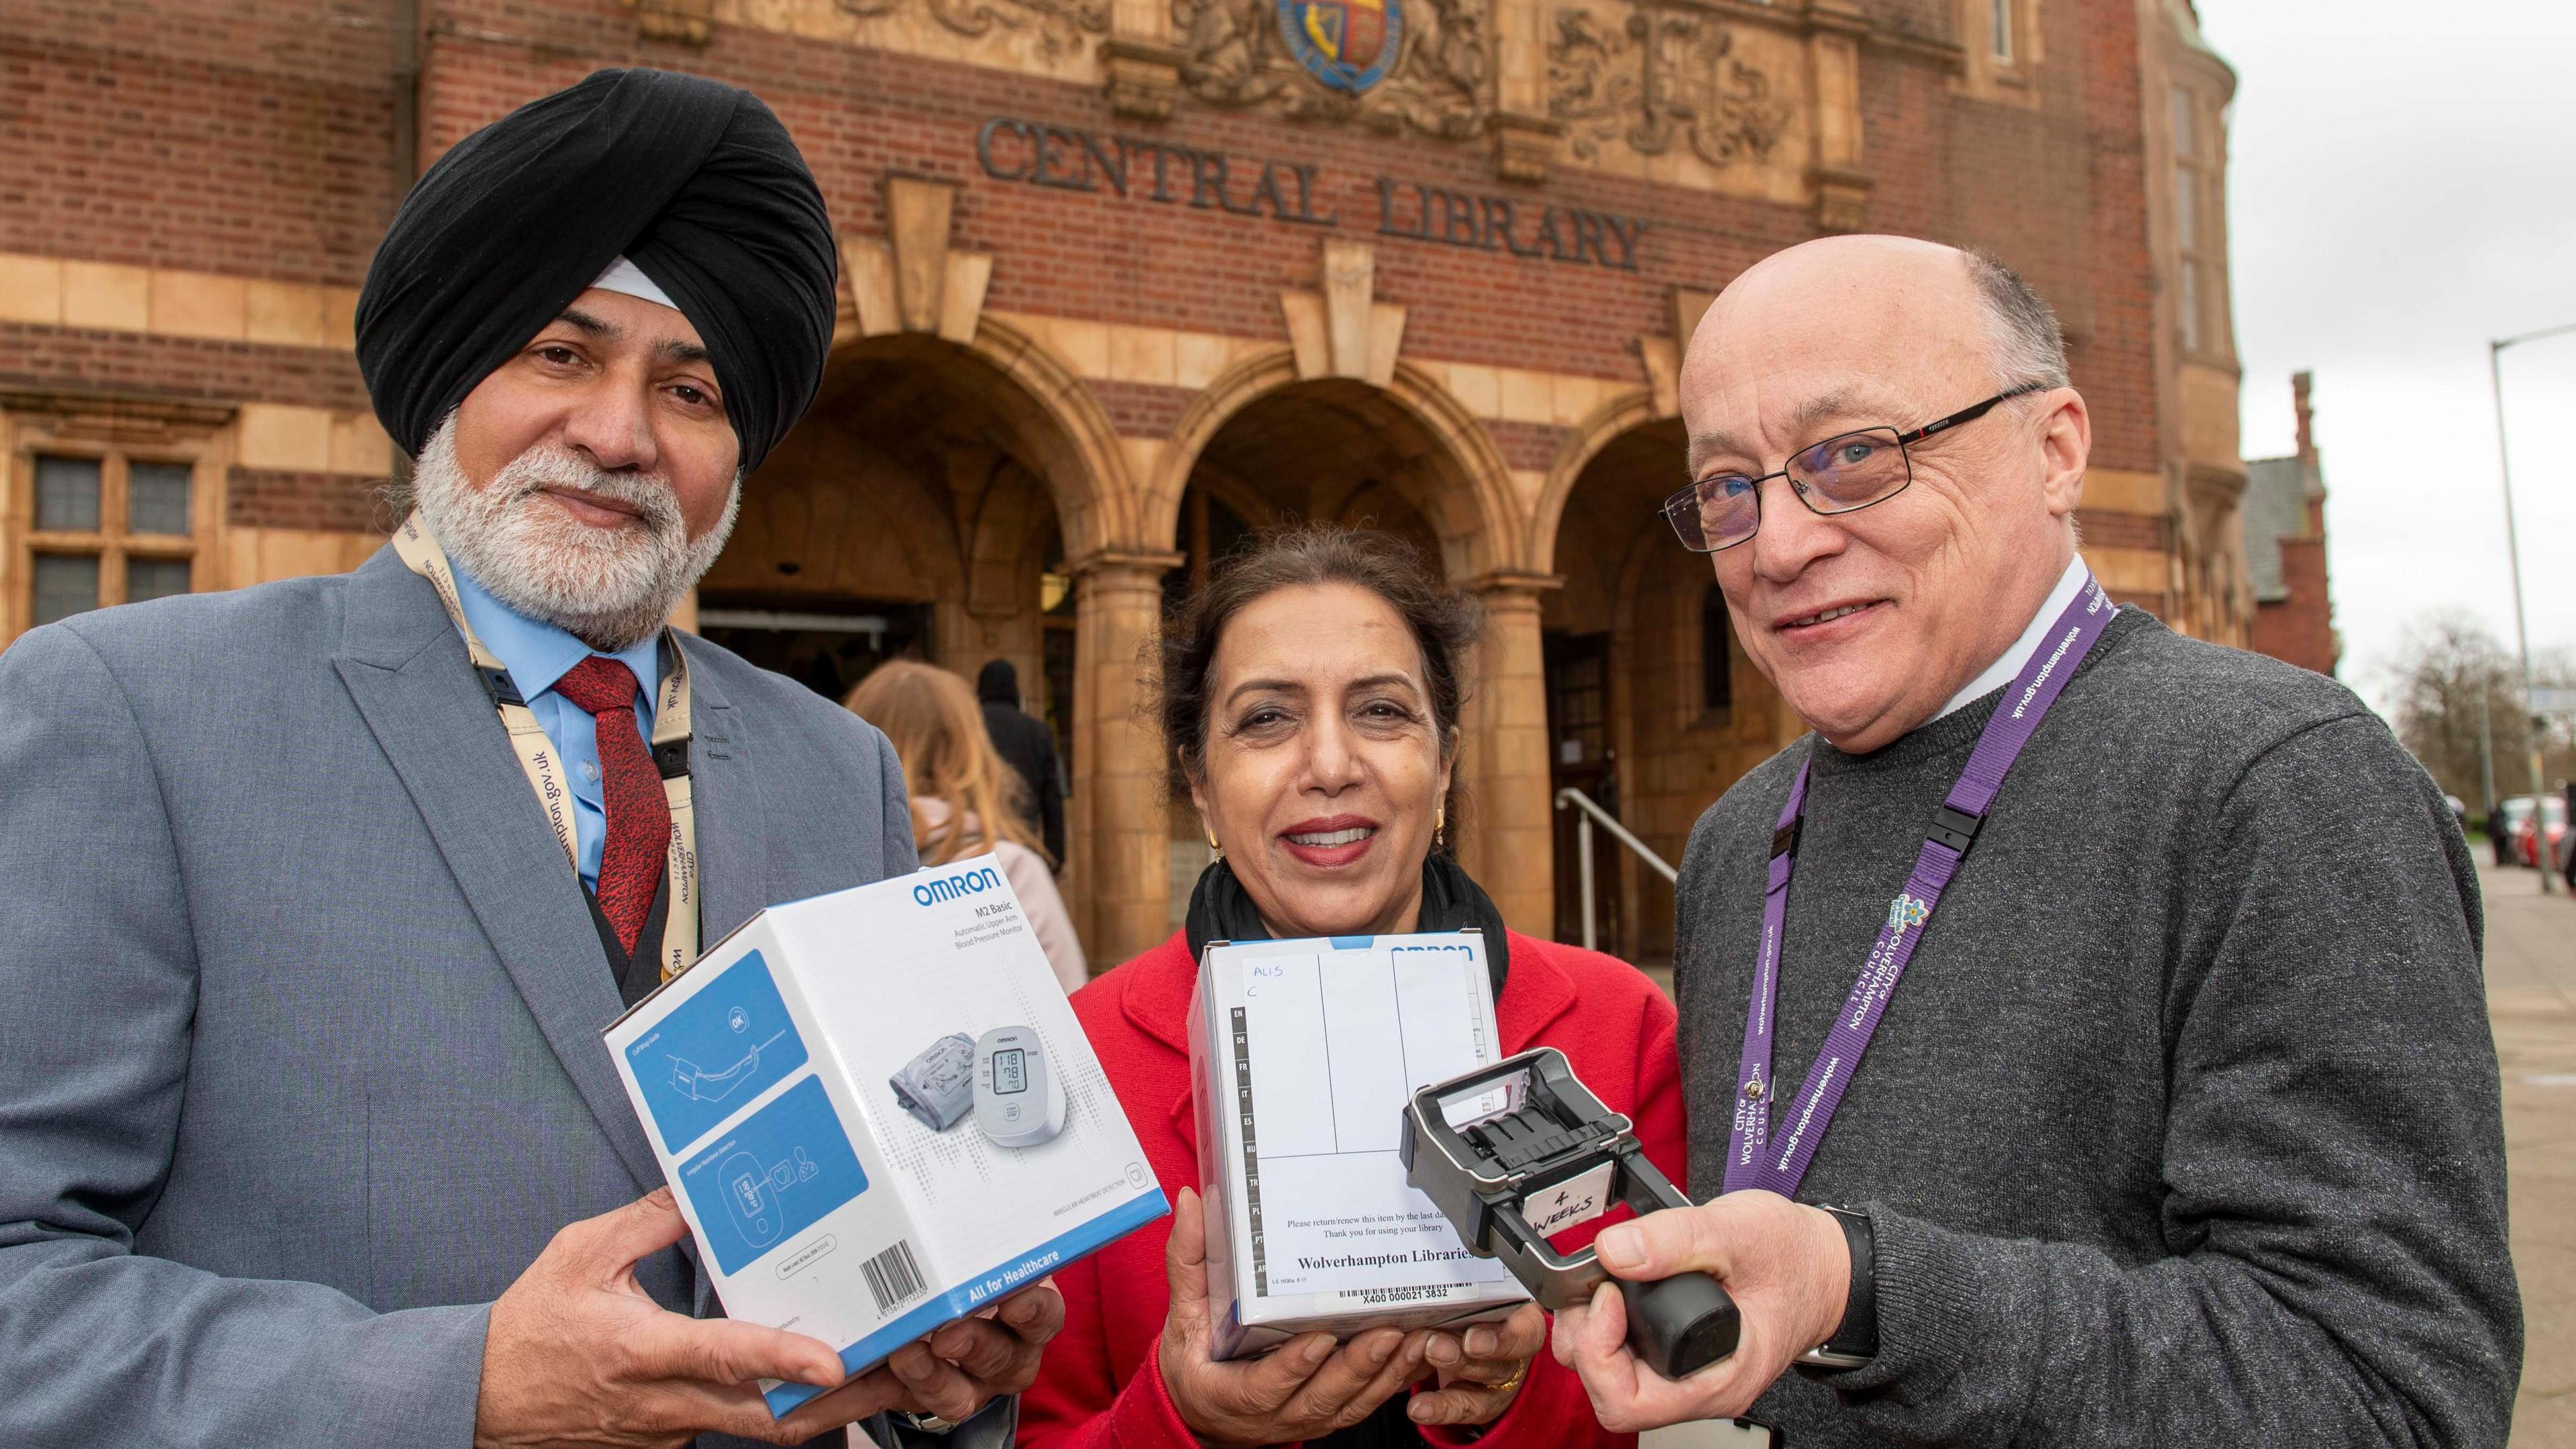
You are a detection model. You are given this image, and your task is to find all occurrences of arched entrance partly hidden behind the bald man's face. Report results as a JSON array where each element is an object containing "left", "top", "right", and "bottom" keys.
[{"left": 1540, "top": 400, "right": 1785, "bottom": 964}]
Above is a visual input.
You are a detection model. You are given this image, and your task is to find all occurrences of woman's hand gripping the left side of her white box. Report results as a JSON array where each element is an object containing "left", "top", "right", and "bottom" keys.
[{"left": 1157, "top": 1189, "right": 1432, "bottom": 1444}]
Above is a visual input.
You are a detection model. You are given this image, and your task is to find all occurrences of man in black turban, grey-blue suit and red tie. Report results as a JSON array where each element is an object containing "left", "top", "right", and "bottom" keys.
[{"left": 0, "top": 70, "right": 1064, "bottom": 1449}]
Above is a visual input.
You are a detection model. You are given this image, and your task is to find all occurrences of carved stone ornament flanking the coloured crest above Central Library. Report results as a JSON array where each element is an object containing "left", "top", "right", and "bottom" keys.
[{"left": 1164, "top": 0, "right": 1497, "bottom": 142}]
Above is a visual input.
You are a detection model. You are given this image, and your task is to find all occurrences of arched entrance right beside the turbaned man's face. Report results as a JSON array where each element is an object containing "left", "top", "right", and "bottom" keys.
[{"left": 698, "top": 327, "right": 1108, "bottom": 938}]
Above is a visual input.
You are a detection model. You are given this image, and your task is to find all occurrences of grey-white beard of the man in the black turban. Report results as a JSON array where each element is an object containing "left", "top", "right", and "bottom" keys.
[{"left": 412, "top": 413, "right": 742, "bottom": 655}]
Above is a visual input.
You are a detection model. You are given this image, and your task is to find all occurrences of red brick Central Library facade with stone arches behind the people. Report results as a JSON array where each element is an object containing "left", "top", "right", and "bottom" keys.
[{"left": 0, "top": 0, "right": 2251, "bottom": 962}]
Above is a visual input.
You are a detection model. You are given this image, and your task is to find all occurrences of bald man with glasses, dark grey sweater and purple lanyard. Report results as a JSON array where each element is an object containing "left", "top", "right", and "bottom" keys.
[{"left": 1554, "top": 237, "right": 2522, "bottom": 1449}]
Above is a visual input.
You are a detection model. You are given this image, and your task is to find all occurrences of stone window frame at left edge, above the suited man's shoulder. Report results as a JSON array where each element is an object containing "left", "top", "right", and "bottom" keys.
[{"left": 0, "top": 392, "right": 234, "bottom": 642}]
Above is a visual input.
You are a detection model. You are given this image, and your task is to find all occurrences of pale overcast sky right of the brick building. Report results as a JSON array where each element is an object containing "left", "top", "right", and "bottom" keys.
[{"left": 2200, "top": 0, "right": 2576, "bottom": 709}]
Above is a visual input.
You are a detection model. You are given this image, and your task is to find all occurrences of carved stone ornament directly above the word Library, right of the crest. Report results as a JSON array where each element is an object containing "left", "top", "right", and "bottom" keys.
[{"left": 1548, "top": 5, "right": 1795, "bottom": 168}]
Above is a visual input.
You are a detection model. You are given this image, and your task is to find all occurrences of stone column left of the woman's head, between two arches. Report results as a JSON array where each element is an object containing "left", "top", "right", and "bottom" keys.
[{"left": 1067, "top": 549, "right": 1180, "bottom": 969}]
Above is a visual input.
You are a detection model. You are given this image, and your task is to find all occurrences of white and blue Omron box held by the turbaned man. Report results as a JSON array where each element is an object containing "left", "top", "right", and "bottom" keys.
[{"left": 605, "top": 856, "right": 1167, "bottom": 1413}]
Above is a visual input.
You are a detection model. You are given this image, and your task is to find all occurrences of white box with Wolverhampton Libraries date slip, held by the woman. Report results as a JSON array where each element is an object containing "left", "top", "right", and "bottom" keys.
[{"left": 1190, "top": 930, "right": 1530, "bottom": 1358}]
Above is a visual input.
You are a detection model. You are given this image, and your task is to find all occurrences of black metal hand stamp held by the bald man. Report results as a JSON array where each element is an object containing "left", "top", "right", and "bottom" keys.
[{"left": 1396, "top": 1046, "right": 1741, "bottom": 1379}]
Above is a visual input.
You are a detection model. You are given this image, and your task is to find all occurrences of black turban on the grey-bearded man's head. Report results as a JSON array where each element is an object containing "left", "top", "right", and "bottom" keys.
[{"left": 358, "top": 70, "right": 835, "bottom": 467}]
